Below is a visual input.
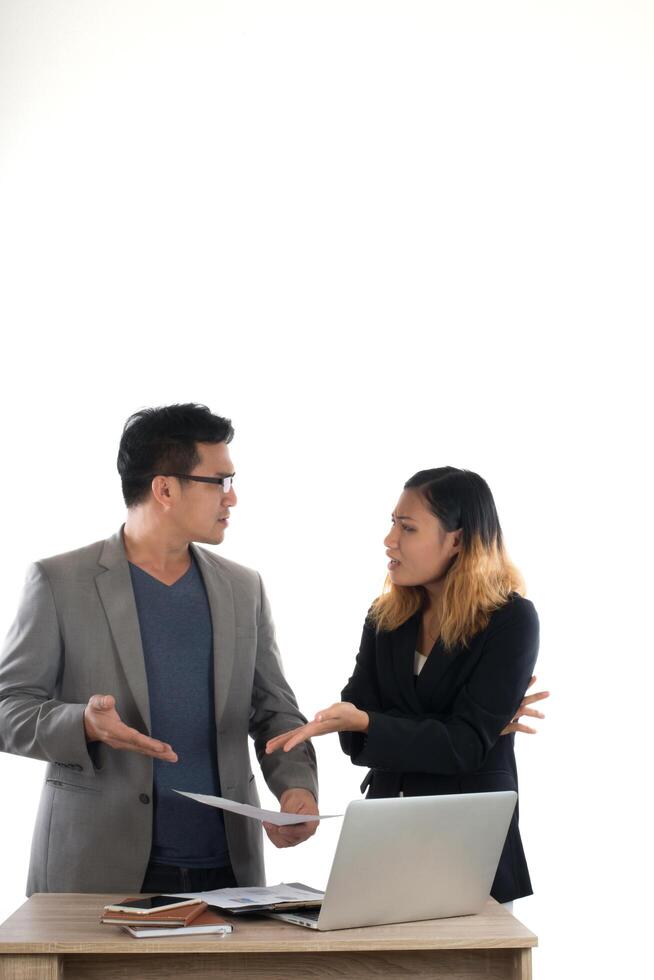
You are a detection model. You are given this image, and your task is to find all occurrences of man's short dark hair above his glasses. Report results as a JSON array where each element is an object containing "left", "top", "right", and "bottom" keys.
[{"left": 117, "top": 404, "right": 234, "bottom": 507}]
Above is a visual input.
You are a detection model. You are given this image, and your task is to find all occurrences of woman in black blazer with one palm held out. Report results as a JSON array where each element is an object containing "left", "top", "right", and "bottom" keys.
[{"left": 267, "top": 466, "right": 547, "bottom": 902}]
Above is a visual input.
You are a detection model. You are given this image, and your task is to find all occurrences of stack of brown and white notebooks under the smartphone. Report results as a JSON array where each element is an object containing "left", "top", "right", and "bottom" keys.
[{"left": 100, "top": 898, "right": 232, "bottom": 939}]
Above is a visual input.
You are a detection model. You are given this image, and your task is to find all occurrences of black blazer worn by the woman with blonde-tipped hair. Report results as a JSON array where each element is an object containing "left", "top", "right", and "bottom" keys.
[{"left": 340, "top": 593, "right": 538, "bottom": 902}]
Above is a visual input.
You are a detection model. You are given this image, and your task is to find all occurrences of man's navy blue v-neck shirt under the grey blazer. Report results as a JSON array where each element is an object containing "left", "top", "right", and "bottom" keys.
[{"left": 129, "top": 559, "right": 229, "bottom": 868}]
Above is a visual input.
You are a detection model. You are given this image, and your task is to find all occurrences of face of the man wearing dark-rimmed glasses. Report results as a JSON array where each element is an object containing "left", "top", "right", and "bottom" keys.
[{"left": 169, "top": 442, "right": 236, "bottom": 544}]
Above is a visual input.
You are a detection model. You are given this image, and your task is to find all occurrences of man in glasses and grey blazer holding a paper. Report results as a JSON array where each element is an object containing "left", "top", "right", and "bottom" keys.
[{"left": 0, "top": 405, "right": 318, "bottom": 895}]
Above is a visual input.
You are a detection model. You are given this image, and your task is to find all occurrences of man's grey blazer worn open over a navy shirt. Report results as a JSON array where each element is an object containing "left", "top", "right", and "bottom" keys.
[{"left": 0, "top": 528, "right": 318, "bottom": 895}]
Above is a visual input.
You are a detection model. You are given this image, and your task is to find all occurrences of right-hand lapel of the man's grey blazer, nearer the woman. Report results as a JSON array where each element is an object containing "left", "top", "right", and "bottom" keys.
[{"left": 191, "top": 544, "right": 236, "bottom": 727}]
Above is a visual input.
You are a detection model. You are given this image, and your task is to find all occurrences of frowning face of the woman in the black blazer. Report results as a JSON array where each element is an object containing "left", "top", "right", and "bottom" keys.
[{"left": 384, "top": 490, "right": 461, "bottom": 585}]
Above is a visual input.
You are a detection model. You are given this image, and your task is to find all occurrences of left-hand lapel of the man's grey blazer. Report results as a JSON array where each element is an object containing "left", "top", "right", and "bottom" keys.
[{"left": 95, "top": 527, "right": 150, "bottom": 734}]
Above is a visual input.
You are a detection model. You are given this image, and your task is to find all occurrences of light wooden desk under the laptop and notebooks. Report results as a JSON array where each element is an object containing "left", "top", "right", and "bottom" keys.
[{"left": 0, "top": 894, "right": 537, "bottom": 980}]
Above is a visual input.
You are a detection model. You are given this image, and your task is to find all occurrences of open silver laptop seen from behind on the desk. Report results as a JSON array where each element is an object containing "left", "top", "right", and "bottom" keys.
[{"left": 265, "top": 792, "right": 517, "bottom": 930}]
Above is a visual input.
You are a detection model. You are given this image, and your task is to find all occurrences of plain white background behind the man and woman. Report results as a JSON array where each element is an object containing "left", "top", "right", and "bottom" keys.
[{"left": 0, "top": 0, "right": 654, "bottom": 977}]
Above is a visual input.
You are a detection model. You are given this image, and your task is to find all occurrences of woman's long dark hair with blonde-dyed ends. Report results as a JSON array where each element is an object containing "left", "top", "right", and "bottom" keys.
[{"left": 369, "top": 466, "right": 525, "bottom": 652}]
